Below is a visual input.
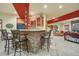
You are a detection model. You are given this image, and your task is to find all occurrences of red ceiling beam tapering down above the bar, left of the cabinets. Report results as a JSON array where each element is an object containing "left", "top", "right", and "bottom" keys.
[{"left": 13, "top": 3, "right": 29, "bottom": 29}]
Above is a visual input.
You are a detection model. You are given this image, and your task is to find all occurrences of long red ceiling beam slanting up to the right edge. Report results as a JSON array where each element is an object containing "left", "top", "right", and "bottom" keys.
[{"left": 47, "top": 10, "right": 79, "bottom": 24}]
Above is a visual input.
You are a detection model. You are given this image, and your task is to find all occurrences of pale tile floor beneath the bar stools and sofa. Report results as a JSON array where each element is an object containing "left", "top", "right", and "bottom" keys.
[{"left": 0, "top": 36, "right": 79, "bottom": 56}]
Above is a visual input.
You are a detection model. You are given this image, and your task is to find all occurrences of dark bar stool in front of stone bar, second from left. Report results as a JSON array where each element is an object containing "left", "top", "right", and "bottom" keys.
[{"left": 11, "top": 30, "right": 27, "bottom": 56}]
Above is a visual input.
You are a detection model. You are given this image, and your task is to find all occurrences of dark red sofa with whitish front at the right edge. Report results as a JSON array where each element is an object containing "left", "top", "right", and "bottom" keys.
[{"left": 64, "top": 32, "right": 79, "bottom": 43}]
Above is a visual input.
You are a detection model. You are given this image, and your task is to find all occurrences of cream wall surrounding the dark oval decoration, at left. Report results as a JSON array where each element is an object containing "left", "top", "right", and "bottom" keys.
[{"left": 0, "top": 14, "right": 17, "bottom": 29}]
